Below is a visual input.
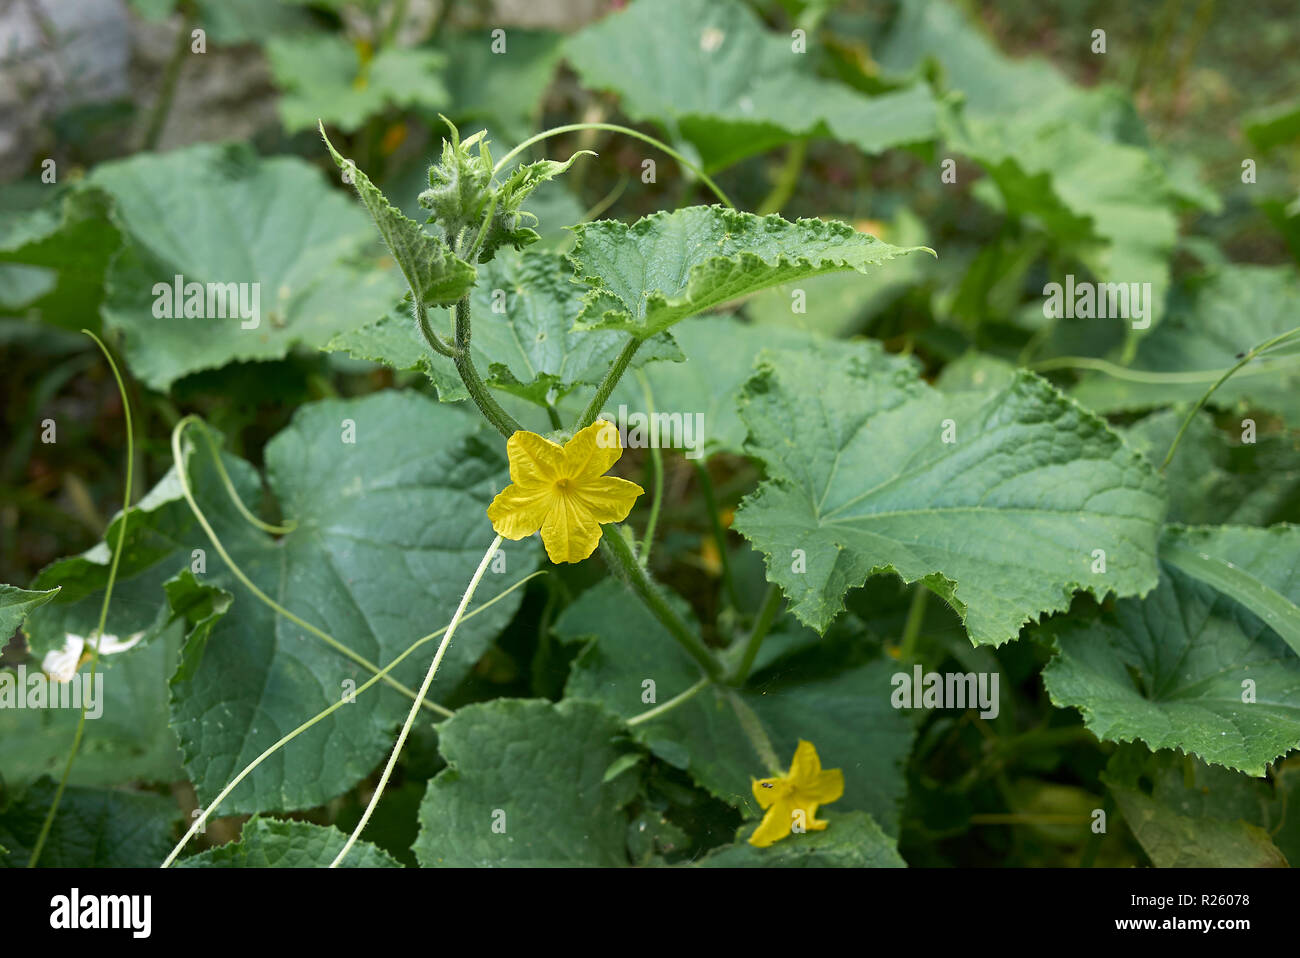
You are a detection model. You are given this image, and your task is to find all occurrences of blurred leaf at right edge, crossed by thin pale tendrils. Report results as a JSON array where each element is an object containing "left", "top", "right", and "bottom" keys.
[{"left": 1071, "top": 265, "right": 1300, "bottom": 420}]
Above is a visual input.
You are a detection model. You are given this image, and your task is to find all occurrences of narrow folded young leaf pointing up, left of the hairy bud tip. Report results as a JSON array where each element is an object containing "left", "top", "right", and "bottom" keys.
[{"left": 320, "top": 126, "right": 477, "bottom": 307}]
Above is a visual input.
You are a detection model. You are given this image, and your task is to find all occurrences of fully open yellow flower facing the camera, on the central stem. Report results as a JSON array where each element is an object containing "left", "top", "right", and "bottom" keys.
[{"left": 488, "top": 420, "right": 645, "bottom": 563}]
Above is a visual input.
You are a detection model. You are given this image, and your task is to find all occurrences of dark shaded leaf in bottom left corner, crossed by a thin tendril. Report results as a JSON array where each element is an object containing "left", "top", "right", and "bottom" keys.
[{"left": 0, "top": 779, "right": 181, "bottom": 868}]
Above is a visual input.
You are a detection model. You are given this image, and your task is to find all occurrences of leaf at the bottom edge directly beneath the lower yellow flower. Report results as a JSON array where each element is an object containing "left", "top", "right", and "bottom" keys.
[{"left": 693, "top": 811, "right": 907, "bottom": 868}]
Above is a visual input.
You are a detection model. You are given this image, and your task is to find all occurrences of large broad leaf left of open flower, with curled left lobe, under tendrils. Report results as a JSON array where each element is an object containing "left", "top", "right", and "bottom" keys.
[{"left": 29, "top": 393, "right": 537, "bottom": 814}]
